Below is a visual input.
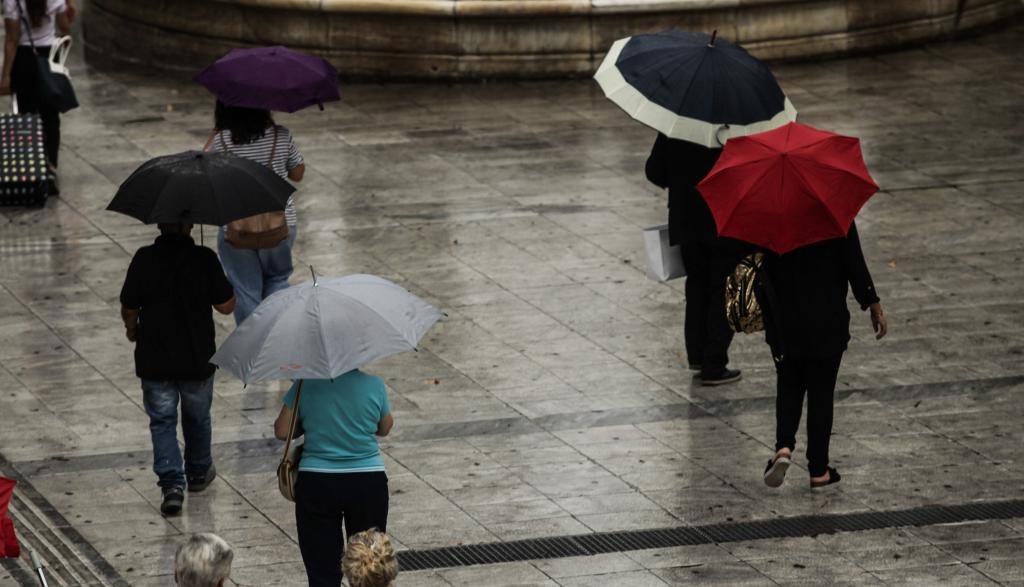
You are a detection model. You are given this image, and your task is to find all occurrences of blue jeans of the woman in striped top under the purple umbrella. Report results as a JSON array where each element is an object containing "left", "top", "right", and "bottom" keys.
[{"left": 217, "top": 226, "right": 298, "bottom": 324}]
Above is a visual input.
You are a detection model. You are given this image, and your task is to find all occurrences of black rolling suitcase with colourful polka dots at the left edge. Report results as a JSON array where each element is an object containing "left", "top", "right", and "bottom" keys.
[{"left": 0, "top": 102, "right": 48, "bottom": 207}]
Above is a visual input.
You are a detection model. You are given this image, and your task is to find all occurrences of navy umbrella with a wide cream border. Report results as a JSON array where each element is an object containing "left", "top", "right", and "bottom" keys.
[{"left": 594, "top": 31, "right": 797, "bottom": 148}]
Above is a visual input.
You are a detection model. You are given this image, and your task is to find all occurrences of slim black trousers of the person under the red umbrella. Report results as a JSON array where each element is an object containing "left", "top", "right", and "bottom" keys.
[{"left": 775, "top": 352, "right": 843, "bottom": 476}]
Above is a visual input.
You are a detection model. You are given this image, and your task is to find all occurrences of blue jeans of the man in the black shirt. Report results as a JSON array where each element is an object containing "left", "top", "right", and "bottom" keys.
[{"left": 142, "top": 375, "right": 213, "bottom": 489}]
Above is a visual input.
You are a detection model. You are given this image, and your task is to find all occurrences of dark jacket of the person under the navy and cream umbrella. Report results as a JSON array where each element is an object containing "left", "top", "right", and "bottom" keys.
[{"left": 645, "top": 133, "right": 722, "bottom": 245}]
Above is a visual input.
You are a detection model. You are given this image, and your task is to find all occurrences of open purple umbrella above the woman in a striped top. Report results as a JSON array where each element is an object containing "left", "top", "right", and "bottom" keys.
[{"left": 196, "top": 46, "right": 341, "bottom": 112}]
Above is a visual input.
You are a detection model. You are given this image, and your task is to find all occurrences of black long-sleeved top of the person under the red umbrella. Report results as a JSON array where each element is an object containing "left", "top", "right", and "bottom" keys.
[{"left": 762, "top": 223, "right": 879, "bottom": 357}]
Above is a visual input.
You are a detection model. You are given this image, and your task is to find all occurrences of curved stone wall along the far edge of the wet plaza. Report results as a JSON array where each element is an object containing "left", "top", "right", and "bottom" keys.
[{"left": 85, "top": 0, "right": 1024, "bottom": 79}]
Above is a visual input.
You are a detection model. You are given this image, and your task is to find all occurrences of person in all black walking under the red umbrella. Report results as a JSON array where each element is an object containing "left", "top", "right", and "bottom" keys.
[{"left": 763, "top": 224, "right": 889, "bottom": 488}]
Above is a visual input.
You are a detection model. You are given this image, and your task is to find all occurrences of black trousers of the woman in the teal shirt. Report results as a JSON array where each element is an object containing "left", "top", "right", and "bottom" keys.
[{"left": 295, "top": 471, "right": 388, "bottom": 587}]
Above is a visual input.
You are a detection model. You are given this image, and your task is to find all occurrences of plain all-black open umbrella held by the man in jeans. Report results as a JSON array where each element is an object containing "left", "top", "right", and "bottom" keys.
[{"left": 106, "top": 151, "right": 295, "bottom": 225}]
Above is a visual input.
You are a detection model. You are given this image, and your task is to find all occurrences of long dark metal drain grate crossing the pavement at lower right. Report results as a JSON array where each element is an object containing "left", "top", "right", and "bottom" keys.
[{"left": 398, "top": 500, "right": 1024, "bottom": 571}]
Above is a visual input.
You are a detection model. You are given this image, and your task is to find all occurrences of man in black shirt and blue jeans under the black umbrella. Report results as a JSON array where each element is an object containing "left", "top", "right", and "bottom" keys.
[{"left": 121, "top": 224, "right": 234, "bottom": 515}]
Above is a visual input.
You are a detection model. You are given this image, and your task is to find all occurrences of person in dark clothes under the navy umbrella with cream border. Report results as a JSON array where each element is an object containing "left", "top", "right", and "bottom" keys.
[{"left": 645, "top": 133, "right": 748, "bottom": 385}]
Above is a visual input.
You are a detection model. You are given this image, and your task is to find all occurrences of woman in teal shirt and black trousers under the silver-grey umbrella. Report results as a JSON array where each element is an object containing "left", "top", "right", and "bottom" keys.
[{"left": 273, "top": 369, "right": 394, "bottom": 587}]
